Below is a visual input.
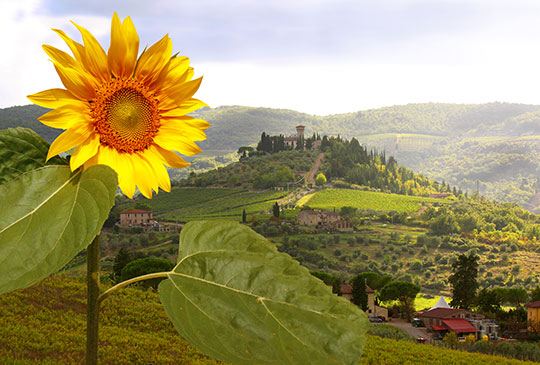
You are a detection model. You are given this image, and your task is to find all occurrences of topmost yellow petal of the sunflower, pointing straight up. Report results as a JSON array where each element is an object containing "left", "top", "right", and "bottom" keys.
[{"left": 107, "top": 13, "right": 139, "bottom": 77}]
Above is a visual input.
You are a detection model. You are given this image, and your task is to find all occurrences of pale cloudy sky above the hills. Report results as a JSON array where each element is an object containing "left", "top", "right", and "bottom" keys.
[{"left": 0, "top": 0, "right": 540, "bottom": 115}]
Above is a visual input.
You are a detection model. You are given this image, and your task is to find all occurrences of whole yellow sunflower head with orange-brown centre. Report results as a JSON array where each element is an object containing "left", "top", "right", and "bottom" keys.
[{"left": 28, "top": 13, "right": 210, "bottom": 198}]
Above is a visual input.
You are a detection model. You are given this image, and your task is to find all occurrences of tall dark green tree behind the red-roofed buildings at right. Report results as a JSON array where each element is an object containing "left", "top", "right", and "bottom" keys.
[{"left": 448, "top": 254, "right": 478, "bottom": 309}]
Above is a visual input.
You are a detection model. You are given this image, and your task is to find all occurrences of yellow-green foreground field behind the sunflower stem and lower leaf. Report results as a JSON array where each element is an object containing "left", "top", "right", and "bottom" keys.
[{"left": 0, "top": 275, "right": 532, "bottom": 365}]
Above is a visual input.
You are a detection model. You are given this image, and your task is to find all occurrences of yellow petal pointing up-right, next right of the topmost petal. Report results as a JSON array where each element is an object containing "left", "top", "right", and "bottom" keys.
[{"left": 135, "top": 35, "right": 172, "bottom": 84}]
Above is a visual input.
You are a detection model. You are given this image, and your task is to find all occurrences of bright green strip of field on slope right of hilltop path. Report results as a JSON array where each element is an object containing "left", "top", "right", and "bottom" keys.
[{"left": 299, "top": 189, "right": 441, "bottom": 213}]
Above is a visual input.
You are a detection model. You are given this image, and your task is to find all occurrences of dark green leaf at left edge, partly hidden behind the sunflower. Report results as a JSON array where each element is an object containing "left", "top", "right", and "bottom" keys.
[{"left": 0, "top": 127, "right": 67, "bottom": 184}]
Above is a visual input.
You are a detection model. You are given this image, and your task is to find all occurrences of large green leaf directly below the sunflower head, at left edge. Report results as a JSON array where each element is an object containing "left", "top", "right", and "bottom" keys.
[{"left": 0, "top": 165, "right": 117, "bottom": 294}]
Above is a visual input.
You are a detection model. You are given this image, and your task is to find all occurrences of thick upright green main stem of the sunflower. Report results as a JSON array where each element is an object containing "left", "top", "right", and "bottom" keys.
[{"left": 86, "top": 234, "right": 100, "bottom": 365}]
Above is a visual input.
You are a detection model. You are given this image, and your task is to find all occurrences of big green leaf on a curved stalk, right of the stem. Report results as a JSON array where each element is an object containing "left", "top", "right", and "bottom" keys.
[{"left": 159, "top": 221, "right": 369, "bottom": 365}]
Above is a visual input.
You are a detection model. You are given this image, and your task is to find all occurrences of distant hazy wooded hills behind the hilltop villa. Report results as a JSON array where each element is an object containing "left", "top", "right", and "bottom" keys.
[{"left": 0, "top": 103, "right": 540, "bottom": 211}]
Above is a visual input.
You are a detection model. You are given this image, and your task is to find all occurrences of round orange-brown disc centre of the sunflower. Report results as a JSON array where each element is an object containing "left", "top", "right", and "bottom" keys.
[{"left": 91, "top": 79, "right": 160, "bottom": 153}]
